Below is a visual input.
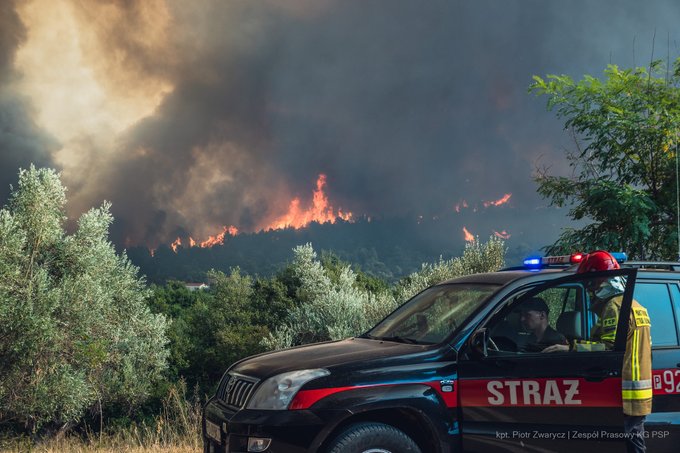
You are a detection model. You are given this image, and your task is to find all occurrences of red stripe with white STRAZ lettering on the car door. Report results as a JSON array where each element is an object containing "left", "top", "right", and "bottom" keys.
[{"left": 459, "top": 378, "right": 622, "bottom": 407}]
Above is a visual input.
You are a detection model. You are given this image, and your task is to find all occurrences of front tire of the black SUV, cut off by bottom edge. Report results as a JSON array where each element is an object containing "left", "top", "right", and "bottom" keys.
[{"left": 326, "top": 422, "right": 421, "bottom": 453}]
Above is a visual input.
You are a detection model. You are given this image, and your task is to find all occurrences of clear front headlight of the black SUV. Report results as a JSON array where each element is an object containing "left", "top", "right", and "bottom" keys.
[{"left": 247, "top": 368, "right": 331, "bottom": 411}]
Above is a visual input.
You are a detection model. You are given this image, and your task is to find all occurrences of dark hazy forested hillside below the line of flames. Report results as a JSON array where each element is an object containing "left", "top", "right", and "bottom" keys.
[{"left": 127, "top": 208, "right": 562, "bottom": 284}]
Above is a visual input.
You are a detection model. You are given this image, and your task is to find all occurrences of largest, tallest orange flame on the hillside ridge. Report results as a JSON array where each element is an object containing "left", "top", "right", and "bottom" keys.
[{"left": 264, "top": 174, "right": 353, "bottom": 231}]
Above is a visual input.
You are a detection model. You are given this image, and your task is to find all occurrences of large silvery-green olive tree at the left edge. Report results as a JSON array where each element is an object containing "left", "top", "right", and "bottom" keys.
[{"left": 0, "top": 166, "right": 167, "bottom": 430}]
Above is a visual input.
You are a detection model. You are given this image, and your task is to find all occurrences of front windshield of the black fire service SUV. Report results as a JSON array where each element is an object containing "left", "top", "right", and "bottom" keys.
[{"left": 365, "top": 283, "right": 498, "bottom": 344}]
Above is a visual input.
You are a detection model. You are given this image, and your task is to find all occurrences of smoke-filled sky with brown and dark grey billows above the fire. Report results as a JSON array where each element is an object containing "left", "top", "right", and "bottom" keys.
[{"left": 0, "top": 0, "right": 680, "bottom": 247}]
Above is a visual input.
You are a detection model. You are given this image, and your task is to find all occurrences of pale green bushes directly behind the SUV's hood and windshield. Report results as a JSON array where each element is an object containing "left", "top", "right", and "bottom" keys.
[{"left": 264, "top": 237, "right": 505, "bottom": 349}]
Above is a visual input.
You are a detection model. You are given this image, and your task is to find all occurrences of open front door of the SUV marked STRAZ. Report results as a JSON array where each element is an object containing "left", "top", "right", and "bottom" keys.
[{"left": 458, "top": 269, "right": 637, "bottom": 452}]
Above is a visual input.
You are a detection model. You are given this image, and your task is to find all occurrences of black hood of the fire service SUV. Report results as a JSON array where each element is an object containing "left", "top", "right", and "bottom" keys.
[{"left": 230, "top": 338, "right": 433, "bottom": 379}]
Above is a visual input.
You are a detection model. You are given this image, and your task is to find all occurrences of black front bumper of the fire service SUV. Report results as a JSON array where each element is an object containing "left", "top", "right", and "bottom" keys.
[{"left": 203, "top": 398, "right": 351, "bottom": 453}]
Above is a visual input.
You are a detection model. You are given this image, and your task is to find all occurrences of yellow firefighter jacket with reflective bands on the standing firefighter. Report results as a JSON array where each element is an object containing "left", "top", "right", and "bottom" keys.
[{"left": 574, "top": 296, "right": 652, "bottom": 415}]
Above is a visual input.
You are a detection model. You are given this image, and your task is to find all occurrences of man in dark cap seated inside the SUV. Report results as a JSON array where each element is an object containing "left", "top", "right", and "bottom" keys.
[{"left": 519, "top": 297, "right": 568, "bottom": 352}]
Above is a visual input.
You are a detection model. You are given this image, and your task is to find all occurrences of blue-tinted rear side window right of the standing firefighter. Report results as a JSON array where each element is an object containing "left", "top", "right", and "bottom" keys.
[{"left": 633, "top": 282, "right": 678, "bottom": 346}]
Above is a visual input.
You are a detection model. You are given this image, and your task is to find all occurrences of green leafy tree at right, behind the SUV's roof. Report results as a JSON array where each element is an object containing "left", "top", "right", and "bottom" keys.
[{"left": 529, "top": 59, "right": 680, "bottom": 259}]
